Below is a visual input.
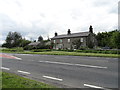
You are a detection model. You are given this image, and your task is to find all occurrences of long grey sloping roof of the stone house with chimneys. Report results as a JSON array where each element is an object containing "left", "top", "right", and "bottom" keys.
[{"left": 51, "top": 32, "right": 90, "bottom": 39}]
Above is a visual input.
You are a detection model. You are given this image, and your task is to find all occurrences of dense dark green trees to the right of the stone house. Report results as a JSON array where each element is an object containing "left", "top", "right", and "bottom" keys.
[{"left": 96, "top": 30, "right": 120, "bottom": 49}]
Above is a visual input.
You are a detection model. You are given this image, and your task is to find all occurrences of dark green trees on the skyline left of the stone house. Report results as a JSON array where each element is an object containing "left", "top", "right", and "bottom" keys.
[{"left": 2, "top": 32, "right": 49, "bottom": 48}]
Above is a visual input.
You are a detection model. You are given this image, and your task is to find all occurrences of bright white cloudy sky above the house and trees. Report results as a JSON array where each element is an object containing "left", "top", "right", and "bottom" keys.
[{"left": 0, "top": 0, "right": 119, "bottom": 44}]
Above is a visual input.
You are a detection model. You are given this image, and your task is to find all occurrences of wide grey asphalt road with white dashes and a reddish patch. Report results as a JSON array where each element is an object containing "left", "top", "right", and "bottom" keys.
[{"left": 0, "top": 54, "right": 118, "bottom": 89}]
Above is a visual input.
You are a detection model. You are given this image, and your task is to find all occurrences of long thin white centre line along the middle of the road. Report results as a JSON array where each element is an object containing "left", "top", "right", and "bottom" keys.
[{"left": 39, "top": 61, "right": 107, "bottom": 69}]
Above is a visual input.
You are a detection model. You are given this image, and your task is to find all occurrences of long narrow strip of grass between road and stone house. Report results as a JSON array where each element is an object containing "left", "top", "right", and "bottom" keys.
[{"left": 2, "top": 48, "right": 120, "bottom": 58}]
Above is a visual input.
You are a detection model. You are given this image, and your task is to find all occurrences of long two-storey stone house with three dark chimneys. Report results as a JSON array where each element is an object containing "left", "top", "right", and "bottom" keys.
[{"left": 51, "top": 26, "right": 96, "bottom": 49}]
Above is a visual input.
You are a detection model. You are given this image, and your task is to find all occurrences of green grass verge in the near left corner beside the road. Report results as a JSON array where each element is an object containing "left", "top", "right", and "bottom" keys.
[{"left": 2, "top": 72, "right": 55, "bottom": 89}]
